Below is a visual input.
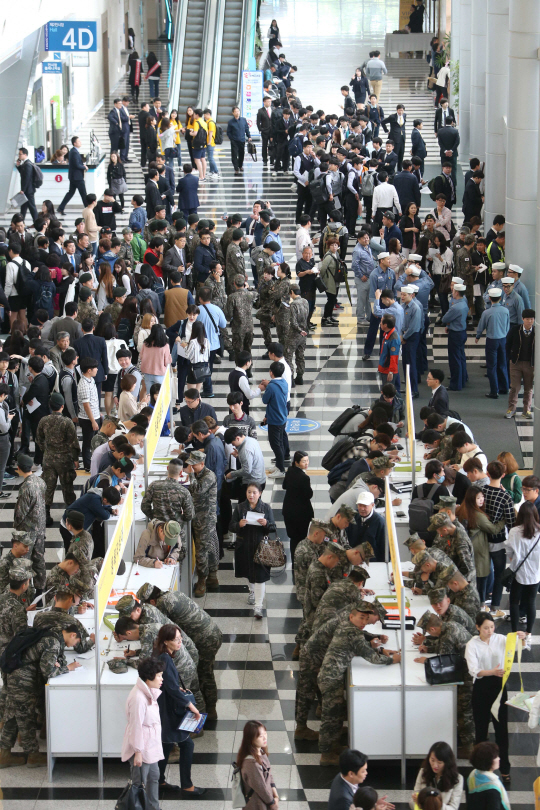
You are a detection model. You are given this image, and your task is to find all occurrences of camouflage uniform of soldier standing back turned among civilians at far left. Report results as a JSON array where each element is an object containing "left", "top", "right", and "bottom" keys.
[{"left": 36, "top": 413, "right": 80, "bottom": 509}]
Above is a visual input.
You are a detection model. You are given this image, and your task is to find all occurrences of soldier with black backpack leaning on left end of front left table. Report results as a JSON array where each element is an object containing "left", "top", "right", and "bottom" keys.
[{"left": 0, "top": 624, "right": 80, "bottom": 768}]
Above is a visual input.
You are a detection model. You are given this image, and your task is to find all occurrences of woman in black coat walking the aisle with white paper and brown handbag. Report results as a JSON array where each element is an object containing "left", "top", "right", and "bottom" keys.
[{"left": 229, "top": 481, "right": 276, "bottom": 619}]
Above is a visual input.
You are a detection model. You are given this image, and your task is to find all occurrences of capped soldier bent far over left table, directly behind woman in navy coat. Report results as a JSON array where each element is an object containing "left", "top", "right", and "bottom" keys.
[{"left": 137, "top": 583, "right": 222, "bottom": 719}]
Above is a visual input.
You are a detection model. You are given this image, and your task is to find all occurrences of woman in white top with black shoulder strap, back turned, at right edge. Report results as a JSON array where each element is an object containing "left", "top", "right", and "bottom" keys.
[{"left": 505, "top": 501, "right": 540, "bottom": 650}]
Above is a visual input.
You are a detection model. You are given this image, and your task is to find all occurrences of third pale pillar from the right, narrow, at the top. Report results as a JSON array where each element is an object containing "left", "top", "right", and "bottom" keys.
[{"left": 470, "top": 0, "right": 487, "bottom": 161}]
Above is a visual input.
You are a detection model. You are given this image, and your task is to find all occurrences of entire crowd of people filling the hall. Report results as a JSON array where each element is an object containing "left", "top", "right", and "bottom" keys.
[{"left": 0, "top": 11, "right": 540, "bottom": 810}]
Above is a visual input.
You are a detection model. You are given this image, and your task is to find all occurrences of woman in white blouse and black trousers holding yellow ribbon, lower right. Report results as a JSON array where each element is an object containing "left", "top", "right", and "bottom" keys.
[{"left": 465, "top": 612, "right": 525, "bottom": 785}]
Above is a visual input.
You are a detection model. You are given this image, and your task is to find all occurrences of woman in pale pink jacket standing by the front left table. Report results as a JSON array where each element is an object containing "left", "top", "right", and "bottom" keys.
[{"left": 122, "top": 658, "right": 163, "bottom": 810}]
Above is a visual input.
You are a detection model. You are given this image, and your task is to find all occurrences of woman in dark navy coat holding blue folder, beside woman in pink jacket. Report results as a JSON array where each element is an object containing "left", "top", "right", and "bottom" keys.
[{"left": 154, "top": 624, "right": 206, "bottom": 798}]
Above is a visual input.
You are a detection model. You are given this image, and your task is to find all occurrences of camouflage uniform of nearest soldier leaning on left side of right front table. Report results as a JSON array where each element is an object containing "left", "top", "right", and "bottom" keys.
[{"left": 317, "top": 617, "right": 393, "bottom": 753}]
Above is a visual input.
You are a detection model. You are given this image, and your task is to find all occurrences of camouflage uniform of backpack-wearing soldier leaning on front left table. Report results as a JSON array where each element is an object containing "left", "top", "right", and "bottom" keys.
[{"left": 0, "top": 631, "right": 68, "bottom": 754}]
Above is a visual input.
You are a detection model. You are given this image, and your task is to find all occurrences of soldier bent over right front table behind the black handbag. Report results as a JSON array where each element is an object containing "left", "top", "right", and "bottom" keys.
[{"left": 414, "top": 614, "right": 475, "bottom": 758}]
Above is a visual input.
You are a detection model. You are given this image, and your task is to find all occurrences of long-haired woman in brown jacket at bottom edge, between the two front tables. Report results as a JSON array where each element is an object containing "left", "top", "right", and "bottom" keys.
[{"left": 236, "top": 720, "right": 278, "bottom": 810}]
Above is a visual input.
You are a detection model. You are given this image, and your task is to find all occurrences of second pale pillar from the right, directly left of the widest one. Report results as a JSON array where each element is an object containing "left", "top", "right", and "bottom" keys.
[{"left": 484, "top": 0, "right": 509, "bottom": 224}]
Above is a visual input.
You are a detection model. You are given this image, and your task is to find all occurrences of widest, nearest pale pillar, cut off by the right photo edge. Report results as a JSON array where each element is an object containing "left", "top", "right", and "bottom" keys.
[{"left": 506, "top": 0, "right": 540, "bottom": 292}]
